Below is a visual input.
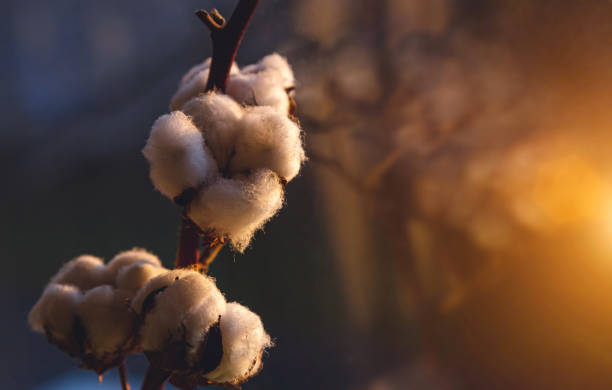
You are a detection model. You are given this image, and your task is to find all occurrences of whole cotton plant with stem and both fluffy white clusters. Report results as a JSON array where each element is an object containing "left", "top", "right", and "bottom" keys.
[{"left": 28, "top": 0, "right": 306, "bottom": 390}]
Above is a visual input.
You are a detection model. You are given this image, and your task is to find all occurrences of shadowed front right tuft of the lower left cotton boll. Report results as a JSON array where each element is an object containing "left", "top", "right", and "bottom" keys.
[{"left": 78, "top": 285, "right": 136, "bottom": 357}]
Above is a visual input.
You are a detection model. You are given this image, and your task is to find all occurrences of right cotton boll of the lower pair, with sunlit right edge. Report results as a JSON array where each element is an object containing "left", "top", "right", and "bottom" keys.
[{"left": 132, "top": 269, "right": 271, "bottom": 388}]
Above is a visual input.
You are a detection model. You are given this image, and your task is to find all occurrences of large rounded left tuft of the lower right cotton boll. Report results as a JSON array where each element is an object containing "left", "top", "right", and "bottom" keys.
[{"left": 132, "top": 269, "right": 225, "bottom": 352}]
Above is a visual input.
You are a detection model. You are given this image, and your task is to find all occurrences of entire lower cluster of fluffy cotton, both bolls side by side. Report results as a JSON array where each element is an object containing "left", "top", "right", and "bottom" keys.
[{"left": 29, "top": 249, "right": 271, "bottom": 385}]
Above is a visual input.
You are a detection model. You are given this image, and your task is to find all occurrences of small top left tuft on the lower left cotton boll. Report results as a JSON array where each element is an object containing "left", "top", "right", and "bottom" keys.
[{"left": 51, "top": 255, "right": 106, "bottom": 291}]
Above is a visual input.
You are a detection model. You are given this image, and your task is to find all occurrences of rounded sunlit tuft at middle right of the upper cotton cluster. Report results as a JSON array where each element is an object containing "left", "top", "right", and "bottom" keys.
[{"left": 230, "top": 107, "right": 306, "bottom": 181}]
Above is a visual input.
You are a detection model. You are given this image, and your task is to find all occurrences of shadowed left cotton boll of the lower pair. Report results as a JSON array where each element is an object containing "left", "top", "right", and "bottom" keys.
[{"left": 29, "top": 249, "right": 165, "bottom": 374}]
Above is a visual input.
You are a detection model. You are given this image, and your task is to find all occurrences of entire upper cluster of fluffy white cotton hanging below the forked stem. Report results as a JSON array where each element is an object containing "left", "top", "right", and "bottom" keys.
[{"left": 143, "top": 54, "right": 306, "bottom": 251}]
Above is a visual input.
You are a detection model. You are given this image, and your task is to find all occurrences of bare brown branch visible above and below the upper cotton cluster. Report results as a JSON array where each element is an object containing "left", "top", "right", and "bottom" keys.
[{"left": 176, "top": 0, "right": 259, "bottom": 271}]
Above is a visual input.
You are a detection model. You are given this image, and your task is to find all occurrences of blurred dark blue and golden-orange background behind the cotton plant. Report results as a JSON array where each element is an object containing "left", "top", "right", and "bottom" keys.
[{"left": 0, "top": 0, "right": 612, "bottom": 390}]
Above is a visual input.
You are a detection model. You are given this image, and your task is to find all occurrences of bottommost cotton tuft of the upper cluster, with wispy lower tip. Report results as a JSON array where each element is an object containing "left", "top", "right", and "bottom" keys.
[{"left": 189, "top": 169, "right": 283, "bottom": 251}]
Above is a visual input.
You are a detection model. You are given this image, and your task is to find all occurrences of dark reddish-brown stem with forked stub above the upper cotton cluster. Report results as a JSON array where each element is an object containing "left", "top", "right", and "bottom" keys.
[{"left": 196, "top": 0, "right": 259, "bottom": 92}]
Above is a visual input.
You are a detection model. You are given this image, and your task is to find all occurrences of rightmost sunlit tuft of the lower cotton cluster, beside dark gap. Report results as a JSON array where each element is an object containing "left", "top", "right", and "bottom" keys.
[{"left": 205, "top": 302, "right": 272, "bottom": 384}]
